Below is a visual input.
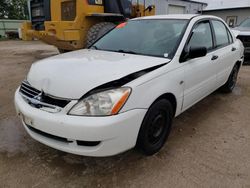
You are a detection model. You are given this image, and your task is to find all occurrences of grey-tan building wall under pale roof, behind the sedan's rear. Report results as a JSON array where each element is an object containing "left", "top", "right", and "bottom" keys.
[{"left": 203, "top": 8, "right": 250, "bottom": 25}]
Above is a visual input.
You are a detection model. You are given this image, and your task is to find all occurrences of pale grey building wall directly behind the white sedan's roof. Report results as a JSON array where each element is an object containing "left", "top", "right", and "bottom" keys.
[{"left": 155, "top": 0, "right": 204, "bottom": 15}]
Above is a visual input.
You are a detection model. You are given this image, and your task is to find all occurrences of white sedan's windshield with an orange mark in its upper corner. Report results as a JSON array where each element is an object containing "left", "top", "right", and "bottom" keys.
[{"left": 91, "top": 19, "right": 188, "bottom": 59}]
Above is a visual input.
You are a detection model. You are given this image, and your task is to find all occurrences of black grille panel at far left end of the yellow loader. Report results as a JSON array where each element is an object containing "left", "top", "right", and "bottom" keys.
[{"left": 30, "top": 0, "right": 51, "bottom": 31}]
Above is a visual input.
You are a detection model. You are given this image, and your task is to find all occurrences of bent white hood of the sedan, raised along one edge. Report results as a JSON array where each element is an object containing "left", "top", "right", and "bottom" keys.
[{"left": 27, "top": 49, "right": 170, "bottom": 99}]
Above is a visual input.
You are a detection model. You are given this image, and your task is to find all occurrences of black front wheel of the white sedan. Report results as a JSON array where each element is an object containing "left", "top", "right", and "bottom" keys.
[{"left": 137, "top": 99, "right": 173, "bottom": 155}]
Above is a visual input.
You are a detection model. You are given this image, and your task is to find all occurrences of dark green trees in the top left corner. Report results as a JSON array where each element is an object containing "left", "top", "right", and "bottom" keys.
[{"left": 0, "top": 0, "right": 28, "bottom": 20}]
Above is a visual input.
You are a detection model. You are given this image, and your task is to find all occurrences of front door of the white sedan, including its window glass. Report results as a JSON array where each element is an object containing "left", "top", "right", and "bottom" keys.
[{"left": 182, "top": 20, "right": 217, "bottom": 111}]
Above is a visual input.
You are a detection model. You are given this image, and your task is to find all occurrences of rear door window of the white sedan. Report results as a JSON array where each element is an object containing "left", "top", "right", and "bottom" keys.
[{"left": 212, "top": 20, "right": 230, "bottom": 47}]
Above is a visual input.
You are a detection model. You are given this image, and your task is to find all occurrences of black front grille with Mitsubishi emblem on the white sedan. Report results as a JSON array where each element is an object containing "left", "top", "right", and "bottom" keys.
[{"left": 20, "top": 81, "right": 70, "bottom": 108}]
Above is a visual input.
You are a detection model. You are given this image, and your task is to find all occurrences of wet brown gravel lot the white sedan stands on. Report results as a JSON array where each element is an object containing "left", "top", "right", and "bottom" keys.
[{"left": 0, "top": 41, "right": 250, "bottom": 188}]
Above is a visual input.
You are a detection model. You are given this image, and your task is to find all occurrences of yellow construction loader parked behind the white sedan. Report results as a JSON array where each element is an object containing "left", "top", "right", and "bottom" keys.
[{"left": 21, "top": 0, "right": 155, "bottom": 52}]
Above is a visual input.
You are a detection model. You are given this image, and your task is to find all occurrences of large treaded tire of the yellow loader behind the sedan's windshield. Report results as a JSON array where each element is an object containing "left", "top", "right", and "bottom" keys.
[{"left": 86, "top": 22, "right": 115, "bottom": 47}]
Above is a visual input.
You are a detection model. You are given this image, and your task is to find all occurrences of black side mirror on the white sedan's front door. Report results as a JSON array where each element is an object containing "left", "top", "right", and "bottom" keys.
[{"left": 180, "top": 47, "right": 207, "bottom": 62}]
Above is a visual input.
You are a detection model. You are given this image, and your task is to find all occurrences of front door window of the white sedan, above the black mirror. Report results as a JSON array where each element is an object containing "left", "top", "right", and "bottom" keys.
[{"left": 187, "top": 22, "right": 213, "bottom": 50}]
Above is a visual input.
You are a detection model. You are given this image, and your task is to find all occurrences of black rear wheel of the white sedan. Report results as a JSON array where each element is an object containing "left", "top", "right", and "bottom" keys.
[{"left": 221, "top": 65, "right": 239, "bottom": 93}]
